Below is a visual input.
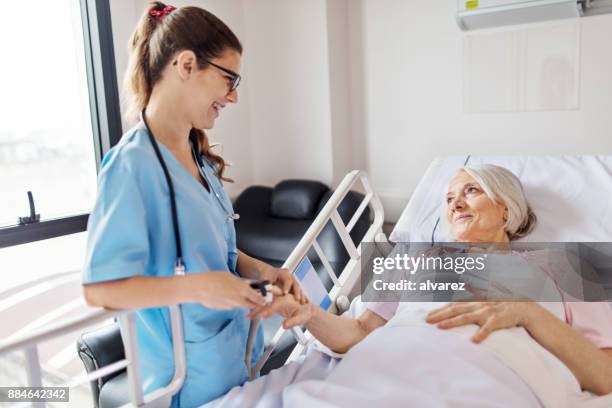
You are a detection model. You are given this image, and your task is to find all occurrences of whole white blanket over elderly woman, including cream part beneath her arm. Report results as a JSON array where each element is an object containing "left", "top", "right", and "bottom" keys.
[{"left": 206, "top": 303, "right": 612, "bottom": 408}]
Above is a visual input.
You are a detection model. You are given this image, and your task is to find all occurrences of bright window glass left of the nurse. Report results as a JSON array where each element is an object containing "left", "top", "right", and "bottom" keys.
[{"left": 0, "top": 1, "right": 96, "bottom": 225}]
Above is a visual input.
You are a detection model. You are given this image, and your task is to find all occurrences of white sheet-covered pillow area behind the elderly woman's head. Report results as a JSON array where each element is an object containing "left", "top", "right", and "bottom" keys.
[{"left": 389, "top": 156, "right": 612, "bottom": 242}]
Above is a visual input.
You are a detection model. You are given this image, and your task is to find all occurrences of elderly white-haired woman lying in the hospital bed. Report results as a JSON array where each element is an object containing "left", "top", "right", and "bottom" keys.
[{"left": 261, "top": 165, "right": 612, "bottom": 395}]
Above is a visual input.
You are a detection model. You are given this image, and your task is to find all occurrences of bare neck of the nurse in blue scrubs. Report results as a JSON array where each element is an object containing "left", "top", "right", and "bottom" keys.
[{"left": 145, "top": 95, "right": 191, "bottom": 158}]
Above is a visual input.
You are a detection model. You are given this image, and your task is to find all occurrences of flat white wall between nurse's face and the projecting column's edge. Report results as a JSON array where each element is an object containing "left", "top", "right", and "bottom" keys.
[{"left": 244, "top": 0, "right": 333, "bottom": 184}]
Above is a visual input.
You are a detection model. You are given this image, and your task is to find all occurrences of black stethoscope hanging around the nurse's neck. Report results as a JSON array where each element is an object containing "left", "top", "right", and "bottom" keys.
[{"left": 140, "top": 111, "right": 240, "bottom": 275}]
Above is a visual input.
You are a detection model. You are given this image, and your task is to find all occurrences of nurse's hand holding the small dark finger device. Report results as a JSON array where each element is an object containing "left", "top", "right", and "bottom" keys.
[{"left": 187, "top": 272, "right": 266, "bottom": 310}]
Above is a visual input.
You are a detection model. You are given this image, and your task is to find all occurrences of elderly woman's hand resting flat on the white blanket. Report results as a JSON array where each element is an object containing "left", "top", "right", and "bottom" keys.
[{"left": 426, "top": 302, "right": 538, "bottom": 343}]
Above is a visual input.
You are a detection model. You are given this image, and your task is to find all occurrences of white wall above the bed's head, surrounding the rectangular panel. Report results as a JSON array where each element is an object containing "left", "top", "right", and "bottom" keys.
[{"left": 363, "top": 0, "right": 612, "bottom": 221}]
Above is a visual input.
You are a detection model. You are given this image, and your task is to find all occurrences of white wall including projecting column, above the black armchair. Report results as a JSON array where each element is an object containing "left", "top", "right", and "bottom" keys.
[{"left": 244, "top": 0, "right": 367, "bottom": 187}]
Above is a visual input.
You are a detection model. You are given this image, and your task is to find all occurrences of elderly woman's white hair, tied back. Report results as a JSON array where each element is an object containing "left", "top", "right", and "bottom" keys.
[{"left": 444, "top": 164, "right": 537, "bottom": 241}]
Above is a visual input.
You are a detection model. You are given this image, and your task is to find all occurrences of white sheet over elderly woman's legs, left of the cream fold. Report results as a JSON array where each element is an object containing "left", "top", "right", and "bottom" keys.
[{"left": 205, "top": 300, "right": 544, "bottom": 408}]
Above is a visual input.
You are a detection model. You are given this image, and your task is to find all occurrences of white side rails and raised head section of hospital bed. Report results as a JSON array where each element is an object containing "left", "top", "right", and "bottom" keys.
[{"left": 0, "top": 156, "right": 612, "bottom": 407}]
